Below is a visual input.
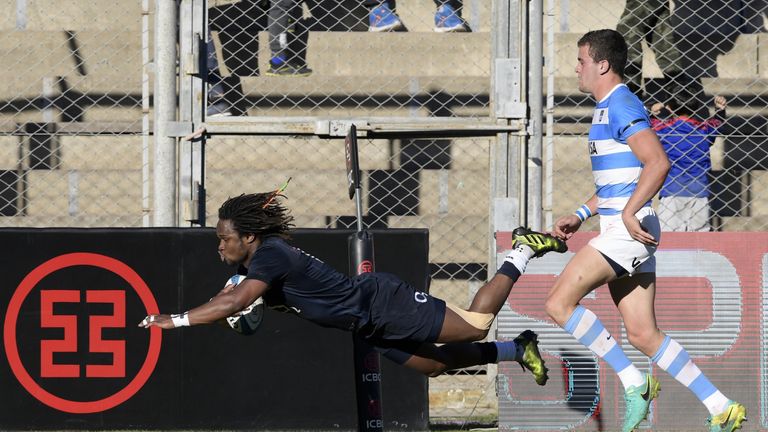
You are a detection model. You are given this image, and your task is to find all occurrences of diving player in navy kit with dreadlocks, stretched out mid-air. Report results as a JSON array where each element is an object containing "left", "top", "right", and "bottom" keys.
[{"left": 139, "top": 189, "right": 568, "bottom": 385}]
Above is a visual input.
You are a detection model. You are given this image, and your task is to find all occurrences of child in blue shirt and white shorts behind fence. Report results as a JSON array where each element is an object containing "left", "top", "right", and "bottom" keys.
[{"left": 651, "top": 92, "right": 726, "bottom": 231}]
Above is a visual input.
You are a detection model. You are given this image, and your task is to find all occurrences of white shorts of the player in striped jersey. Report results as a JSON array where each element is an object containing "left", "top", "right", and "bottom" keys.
[{"left": 589, "top": 207, "right": 661, "bottom": 275}]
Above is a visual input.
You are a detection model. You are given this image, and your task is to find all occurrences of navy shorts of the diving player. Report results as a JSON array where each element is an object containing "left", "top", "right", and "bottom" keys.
[{"left": 356, "top": 273, "right": 445, "bottom": 364}]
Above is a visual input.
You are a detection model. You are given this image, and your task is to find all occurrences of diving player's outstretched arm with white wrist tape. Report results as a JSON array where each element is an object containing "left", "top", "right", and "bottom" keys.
[{"left": 139, "top": 279, "right": 268, "bottom": 329}]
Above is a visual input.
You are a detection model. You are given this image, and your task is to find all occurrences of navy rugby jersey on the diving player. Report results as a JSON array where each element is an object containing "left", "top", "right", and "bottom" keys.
[{"left": 240, "top": 236, "right": 375, "bottom": 330}]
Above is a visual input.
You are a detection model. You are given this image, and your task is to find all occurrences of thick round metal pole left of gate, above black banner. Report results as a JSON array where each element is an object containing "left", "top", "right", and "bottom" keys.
[{"left": 153, "top": 0, "right": 178, "bottom": 227}]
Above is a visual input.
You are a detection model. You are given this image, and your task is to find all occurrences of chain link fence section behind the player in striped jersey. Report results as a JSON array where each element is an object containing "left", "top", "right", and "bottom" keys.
[{"left": 544, "top": 0, "right": 768, "bottom": 231}]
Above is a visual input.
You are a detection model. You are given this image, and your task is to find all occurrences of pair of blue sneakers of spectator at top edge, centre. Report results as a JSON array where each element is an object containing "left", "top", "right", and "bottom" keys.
[{"left": 364, "top": 0, "right": 468, "bottom": 33}]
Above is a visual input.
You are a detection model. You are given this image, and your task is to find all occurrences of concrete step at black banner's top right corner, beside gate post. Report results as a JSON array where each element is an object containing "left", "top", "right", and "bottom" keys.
[{"left": 388, "top": 214, "right": 488, "bottom": 262}]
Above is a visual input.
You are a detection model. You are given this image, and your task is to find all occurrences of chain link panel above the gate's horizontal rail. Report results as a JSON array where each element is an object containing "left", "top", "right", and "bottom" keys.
[{"left": 208, "top": 0, "right": 491, "bottom": 117}]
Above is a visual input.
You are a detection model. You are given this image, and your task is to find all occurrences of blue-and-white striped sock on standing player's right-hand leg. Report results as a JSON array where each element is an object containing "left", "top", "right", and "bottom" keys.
[{"left": 651, "top": 336, "right": 729, "bottom": 415}]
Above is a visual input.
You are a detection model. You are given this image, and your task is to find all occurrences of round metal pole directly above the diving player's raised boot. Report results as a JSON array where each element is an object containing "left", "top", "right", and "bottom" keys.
[{"left": 527, "top": 0, "right": 544, "bottom": 231}]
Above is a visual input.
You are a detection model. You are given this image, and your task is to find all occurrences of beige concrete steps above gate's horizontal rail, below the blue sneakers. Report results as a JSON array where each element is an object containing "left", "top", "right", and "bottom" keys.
[{"left": 231, "top": 32, "right": 490, "bottom": 116}]
